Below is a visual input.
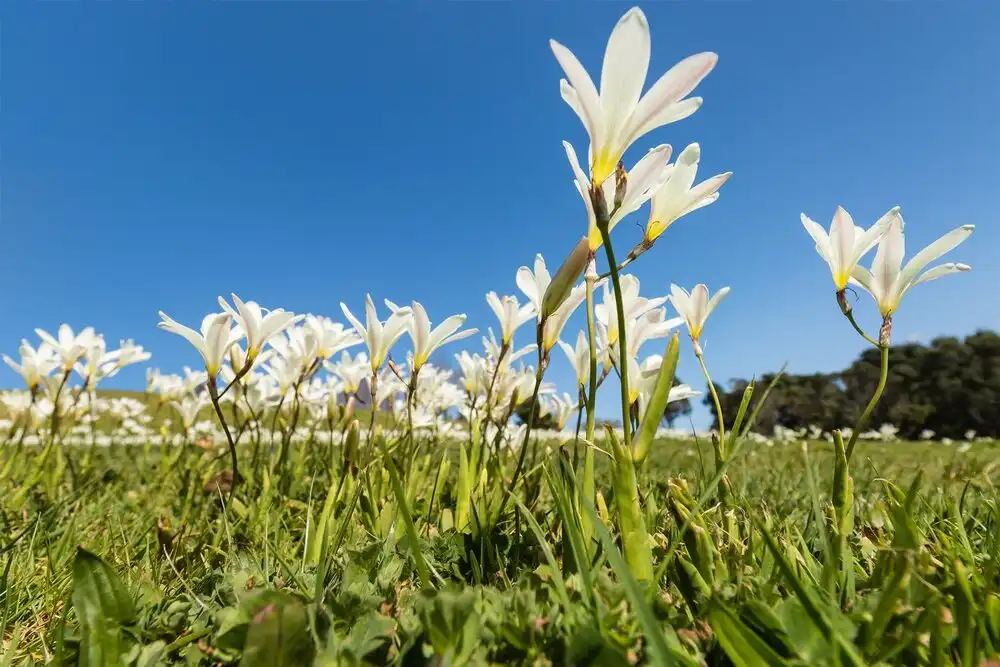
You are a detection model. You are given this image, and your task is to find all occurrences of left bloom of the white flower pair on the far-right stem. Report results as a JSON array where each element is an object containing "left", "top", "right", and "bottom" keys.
[{"left": 801, "top": 206, "right": 902, "bottom": 292}]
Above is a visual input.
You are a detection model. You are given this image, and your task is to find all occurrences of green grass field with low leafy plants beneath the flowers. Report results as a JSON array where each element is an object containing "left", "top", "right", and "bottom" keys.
[{"left": 0, "top": 440, "right": 1000, "bottom": 665}]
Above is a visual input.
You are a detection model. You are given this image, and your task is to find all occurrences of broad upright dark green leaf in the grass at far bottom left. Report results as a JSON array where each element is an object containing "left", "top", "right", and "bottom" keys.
[{"left": 72, "top": 547, "right": 135, "bottom": 667}]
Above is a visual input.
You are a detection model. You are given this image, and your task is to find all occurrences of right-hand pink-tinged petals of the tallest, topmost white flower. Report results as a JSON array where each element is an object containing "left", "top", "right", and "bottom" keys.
[{"left": 627, "top": 52, "right": 719, "bottom": 144}]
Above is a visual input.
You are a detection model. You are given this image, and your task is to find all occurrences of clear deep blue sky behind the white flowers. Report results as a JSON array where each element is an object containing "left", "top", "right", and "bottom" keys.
[{"left": 0, "top": 1, "right": 1000, "bottom": 428}]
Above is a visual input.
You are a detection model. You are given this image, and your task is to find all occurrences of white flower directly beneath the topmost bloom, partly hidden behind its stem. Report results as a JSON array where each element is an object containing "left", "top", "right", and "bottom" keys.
[{"left": 563, "top": 141, "right": 670, "bottom": 252}]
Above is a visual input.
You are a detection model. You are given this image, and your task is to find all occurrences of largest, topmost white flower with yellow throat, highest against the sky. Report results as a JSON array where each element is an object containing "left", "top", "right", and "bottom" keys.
[{"left": 549, "top": 7, "right": 718, "bottom": 185}]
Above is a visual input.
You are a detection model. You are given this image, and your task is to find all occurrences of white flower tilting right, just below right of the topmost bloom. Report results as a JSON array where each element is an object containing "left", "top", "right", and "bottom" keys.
[{"left": 645, "top": 144, "right": 733, "bottom": 243}]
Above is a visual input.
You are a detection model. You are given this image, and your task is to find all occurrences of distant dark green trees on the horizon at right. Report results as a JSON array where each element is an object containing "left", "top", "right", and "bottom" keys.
[{"left": 702, "top": 331, "right": 1000, "bottom": 439}]
